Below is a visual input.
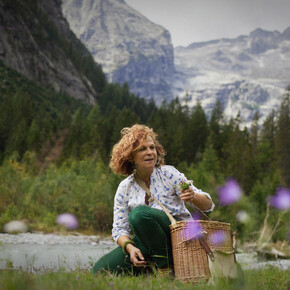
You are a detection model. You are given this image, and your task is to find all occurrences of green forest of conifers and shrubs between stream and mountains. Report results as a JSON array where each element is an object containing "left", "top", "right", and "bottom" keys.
[{"left": 0, "top": 53, "right": 290, "bottom": 241}]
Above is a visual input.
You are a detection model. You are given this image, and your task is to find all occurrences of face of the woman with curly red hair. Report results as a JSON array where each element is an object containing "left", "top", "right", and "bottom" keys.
[{"left": 134, "top": 137, "right": 157, "bottom": 170}]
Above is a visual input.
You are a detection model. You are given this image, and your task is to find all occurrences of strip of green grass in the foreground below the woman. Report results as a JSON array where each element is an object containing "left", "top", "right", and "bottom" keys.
[{"left": 0, "top": 267, "right": 290, "bottom": 290}]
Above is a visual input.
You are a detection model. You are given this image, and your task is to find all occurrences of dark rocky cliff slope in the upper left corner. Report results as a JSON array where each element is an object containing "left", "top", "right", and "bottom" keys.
[{"left": 0, "top": 0, "right": 106, "bottom": 104}]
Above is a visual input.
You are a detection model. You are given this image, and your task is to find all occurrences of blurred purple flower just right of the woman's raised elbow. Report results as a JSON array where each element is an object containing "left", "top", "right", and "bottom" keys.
[{"left": 218, "top": 178, "right": 242, "bottom": 206}]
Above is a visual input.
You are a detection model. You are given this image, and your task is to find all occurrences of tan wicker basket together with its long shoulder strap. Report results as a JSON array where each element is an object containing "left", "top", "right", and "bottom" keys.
[{"left": 134, "top": 174, "right": 235, "bottom": 283}]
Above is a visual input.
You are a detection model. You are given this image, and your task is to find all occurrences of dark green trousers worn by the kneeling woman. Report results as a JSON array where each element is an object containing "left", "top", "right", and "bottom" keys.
[{"left": 92, "top": 206, "right": 172, "bottom": 274}]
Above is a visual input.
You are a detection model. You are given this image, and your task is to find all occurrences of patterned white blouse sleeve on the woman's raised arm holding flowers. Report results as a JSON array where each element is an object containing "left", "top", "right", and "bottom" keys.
[{"left": 167, "top": 166, "right": 215, "bottom": 212}]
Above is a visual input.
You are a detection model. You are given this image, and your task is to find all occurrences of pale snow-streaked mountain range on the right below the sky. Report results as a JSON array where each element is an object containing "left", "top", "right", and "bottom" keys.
[{"left": 172, "top": 27, "right": 290, "bottom": 125}]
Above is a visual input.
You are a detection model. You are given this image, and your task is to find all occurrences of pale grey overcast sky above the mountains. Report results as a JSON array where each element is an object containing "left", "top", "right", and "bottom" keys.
[{"left": 125, "top": 0, "right": 290, "bottom": 47}]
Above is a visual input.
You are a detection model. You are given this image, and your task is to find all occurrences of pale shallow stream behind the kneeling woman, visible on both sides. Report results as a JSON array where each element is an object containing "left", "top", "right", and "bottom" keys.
[{"left": 0, "top": 233, "right": 290, "bottom": 272}]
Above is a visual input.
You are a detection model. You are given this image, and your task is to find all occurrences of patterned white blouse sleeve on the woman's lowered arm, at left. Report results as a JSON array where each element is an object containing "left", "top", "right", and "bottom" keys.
[{"left": 112, "top": 182, "right": 130, "bottom": 242}]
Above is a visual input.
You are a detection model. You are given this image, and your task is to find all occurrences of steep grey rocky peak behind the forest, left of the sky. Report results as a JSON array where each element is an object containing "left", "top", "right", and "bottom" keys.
[{"left": 62, "top": 0, "right": 174, "bottom": 103}]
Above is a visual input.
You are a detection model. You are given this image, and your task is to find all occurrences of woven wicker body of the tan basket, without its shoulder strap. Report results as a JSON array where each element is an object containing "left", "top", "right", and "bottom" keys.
[{"left": 170, "top": 220, "right": 234, "bottom": 283}]
